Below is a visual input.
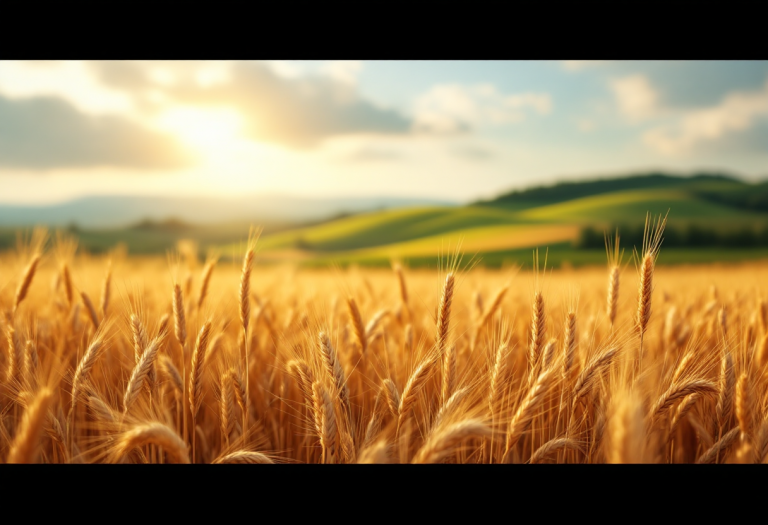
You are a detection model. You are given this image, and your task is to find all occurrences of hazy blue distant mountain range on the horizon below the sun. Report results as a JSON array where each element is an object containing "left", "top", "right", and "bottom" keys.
[{"left": 0, "top": 195, "right": 455, "bottom": 228}]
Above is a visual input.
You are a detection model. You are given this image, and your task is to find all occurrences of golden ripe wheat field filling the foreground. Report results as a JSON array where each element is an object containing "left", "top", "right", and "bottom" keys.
[{"left": 0, "top": 227, "right": 768, "bottom": 463}]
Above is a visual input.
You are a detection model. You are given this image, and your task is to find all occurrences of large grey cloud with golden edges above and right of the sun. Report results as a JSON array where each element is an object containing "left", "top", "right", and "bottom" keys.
[{"left": 91, "top": 61, "right": 411, "bottom": 148}]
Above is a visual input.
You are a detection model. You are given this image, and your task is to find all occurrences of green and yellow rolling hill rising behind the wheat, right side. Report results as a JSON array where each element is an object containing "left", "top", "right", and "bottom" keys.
[{"left": 240, "top": 174, "right": 768, "bottom": 263}]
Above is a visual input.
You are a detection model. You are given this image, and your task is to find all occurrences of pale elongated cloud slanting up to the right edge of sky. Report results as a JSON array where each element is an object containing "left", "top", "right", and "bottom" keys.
[{"left": 643, "top": 78, "right": 768, "bottom": 155}]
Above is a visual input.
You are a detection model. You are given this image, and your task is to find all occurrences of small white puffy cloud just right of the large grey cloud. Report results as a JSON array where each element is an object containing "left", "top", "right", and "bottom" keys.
[{"left": 413, "top": 84, "right": 552, "bottom": 133}]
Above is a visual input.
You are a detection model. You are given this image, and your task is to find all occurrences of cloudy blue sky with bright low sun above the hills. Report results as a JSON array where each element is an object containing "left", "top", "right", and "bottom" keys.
[{"left": 0, "top": 60, "right": 768, "bottom": 204}]
